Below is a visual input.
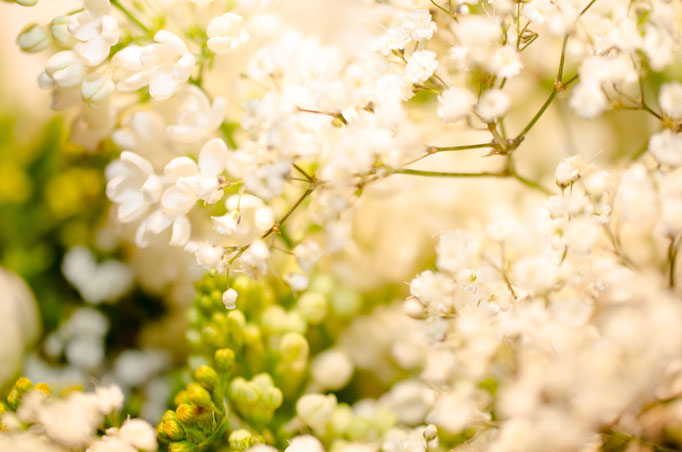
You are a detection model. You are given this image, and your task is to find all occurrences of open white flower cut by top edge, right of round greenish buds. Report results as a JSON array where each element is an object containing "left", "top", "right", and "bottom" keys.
[{"left": 68, "top": 0, "right": 118, "bottom": 66}]
